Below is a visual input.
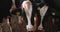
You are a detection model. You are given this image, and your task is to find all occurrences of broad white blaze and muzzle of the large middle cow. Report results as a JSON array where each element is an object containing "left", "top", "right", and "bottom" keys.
[{"left": 22, "top": 0, "right": 33, "bottom": 31}]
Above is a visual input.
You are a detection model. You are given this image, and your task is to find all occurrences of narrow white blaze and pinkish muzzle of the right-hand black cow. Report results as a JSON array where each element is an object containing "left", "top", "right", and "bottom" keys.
[{"left": 38, "top": 5, "right": 48, "bottom": 30}]
